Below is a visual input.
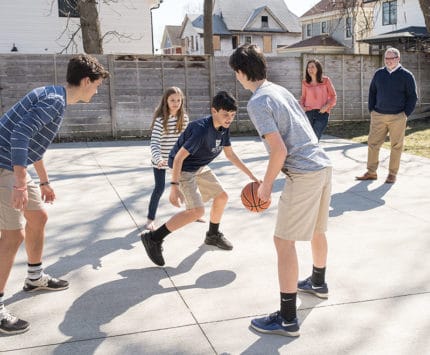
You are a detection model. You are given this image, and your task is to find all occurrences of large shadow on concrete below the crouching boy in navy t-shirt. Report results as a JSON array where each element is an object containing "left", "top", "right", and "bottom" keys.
[{"left": 54, "top": 246, "right": 236, "bottom": 355}]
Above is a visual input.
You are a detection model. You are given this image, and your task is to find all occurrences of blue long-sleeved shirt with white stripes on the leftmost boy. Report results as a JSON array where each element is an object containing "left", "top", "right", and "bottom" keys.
[{"left": 0, "top": 86, "right": 67, "bottom": 170}]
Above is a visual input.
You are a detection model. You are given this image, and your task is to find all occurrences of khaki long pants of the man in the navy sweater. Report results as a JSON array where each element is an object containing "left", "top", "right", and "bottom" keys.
[{"left": 367, "top": 111, "right": 407, "bottom": 176}]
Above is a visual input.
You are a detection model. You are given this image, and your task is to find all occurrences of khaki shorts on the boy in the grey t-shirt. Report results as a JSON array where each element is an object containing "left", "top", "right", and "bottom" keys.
[{"left": 275, "top": 167, "right": 332, "bottom": 241}]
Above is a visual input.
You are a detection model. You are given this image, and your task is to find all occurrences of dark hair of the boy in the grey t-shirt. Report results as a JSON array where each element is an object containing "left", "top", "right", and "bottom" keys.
[{"left": 229, "top": 44, "right": 267, "bottom": 81}]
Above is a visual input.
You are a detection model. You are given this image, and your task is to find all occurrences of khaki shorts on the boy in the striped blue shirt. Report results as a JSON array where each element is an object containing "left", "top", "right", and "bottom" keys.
[{"left": 0, "top": 168, "right": 43, "bottom": 230}]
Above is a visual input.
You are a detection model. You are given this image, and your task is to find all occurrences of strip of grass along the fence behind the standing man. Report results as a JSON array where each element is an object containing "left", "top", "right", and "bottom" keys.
[{"left": 325, "top": 118, "right": 430, "bottom": 158}]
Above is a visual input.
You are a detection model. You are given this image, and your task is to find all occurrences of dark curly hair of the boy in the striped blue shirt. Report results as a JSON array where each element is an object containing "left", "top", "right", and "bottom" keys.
[{"left": 66, "top": 54, "right": 109, "bottom": 86}]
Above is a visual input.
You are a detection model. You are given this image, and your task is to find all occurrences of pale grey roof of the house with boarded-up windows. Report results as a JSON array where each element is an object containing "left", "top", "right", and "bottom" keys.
[{"left": 214, "top": 0, "right": 301, "bottom": 32}]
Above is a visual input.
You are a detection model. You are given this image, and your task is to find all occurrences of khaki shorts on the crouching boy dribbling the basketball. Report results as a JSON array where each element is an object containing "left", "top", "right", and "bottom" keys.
[{"left": 179, "top": 166, "right": 225, "bottom": 210}]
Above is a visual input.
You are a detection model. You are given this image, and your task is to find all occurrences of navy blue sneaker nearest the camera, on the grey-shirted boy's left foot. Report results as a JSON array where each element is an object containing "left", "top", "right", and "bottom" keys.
[{"left": 251, "top": 311, "right": 300, "bottom": 337}]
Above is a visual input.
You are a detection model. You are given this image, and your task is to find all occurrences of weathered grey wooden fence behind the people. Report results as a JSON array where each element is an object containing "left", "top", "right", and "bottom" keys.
[{"left": 0, "top": 53, "right": 430, "bottom": 138}]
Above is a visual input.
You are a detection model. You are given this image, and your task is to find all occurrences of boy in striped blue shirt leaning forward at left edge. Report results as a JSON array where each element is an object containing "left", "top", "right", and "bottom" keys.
[{"left": 0, "top": 55, "right": 109, "bottom": 334}]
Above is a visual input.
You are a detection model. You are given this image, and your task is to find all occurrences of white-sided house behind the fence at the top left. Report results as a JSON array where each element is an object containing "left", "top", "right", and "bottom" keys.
[{"left": 0, "top": 0, "right": 162, "bottom": 54}]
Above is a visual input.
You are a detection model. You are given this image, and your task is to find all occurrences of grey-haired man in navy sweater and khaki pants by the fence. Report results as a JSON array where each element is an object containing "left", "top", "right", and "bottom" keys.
[{"left": 356, "top": 48, "right": 417, "bottom": 184}]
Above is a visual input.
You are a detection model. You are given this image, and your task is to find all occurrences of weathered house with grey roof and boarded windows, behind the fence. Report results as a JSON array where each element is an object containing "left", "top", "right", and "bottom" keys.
[{"left": 170, "top": 0, "right": 301, "bottom": 56}]
